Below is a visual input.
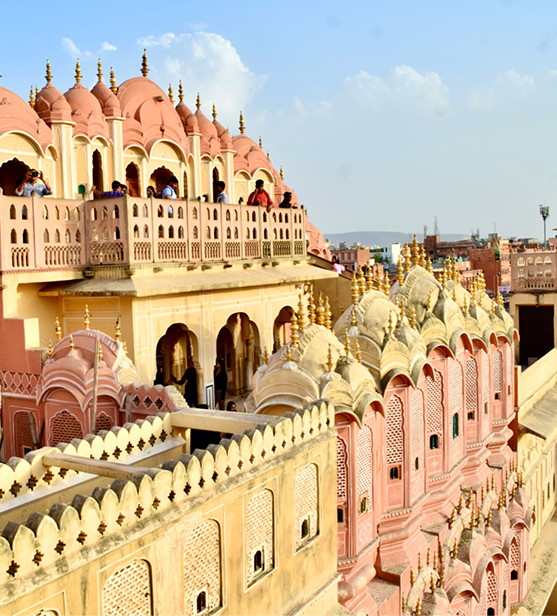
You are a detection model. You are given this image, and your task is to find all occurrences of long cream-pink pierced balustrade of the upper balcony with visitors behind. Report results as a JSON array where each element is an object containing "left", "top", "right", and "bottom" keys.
[{"left": 0, "top": 195, "right": 306, "bottom": 272}]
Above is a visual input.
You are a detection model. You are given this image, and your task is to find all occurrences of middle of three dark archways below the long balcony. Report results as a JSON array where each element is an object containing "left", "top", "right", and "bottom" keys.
[{"left": 217, "top": 312, "right": 261, "bottom": 395}]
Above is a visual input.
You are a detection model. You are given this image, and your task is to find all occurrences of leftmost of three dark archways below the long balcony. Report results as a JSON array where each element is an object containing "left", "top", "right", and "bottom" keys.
[{"left": 155, "top": 323, "right": 202, "bottom": 407}]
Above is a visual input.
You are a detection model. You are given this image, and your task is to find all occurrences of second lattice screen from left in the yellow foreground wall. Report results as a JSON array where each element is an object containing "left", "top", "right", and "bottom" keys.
[{"left": 184, "top": 520, "right": 221, "bottom": 616}]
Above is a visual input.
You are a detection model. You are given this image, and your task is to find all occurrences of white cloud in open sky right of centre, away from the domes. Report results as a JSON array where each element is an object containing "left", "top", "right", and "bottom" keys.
[{"left": 346, "top": 65, "right": 450, "bottom": 116}]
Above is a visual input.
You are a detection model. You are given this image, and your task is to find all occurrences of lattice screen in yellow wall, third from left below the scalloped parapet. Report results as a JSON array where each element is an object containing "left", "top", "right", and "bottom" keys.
[{"left": 246, "top": 490, "right": 275, "bottom": 584}]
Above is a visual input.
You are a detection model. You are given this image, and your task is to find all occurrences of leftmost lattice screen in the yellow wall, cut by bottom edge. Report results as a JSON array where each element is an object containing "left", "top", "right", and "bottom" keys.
[{"left": 102, "top": 559, "right": 152, "bottom": 616}]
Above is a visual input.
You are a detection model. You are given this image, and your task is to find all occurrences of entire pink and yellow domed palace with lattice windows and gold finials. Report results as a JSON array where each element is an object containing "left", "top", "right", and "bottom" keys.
[{"left": 0, "top": 56, "right": 535, "bottom": 616}]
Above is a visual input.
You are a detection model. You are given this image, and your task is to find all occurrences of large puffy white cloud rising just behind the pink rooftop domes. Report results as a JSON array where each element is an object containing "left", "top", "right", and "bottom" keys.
[{"left": 137, "top": 31, "right": 267, "bottom": 126}]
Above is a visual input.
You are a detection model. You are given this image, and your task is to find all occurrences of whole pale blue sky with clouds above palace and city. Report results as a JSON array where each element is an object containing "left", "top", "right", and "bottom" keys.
[{"left": 0, "top": 0, "right": 557, "bottom": 237}]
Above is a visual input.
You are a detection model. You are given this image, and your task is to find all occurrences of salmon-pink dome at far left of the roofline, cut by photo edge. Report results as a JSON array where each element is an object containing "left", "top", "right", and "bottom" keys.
[{"left": 0, "top": 86, "right": 52, "bottom": 152}]
